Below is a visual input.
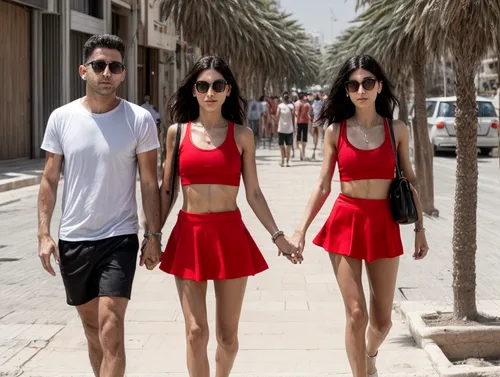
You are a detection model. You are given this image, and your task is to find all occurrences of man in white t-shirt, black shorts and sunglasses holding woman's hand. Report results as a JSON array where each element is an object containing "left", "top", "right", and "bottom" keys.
[{"left": 38, "top": 35, "right": 161, "bottom": 377}]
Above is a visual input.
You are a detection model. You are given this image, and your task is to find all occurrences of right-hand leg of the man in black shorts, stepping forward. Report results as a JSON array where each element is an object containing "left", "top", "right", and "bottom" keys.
[{"left": 98, "top": 297, "right": 129, "bottom": 377}]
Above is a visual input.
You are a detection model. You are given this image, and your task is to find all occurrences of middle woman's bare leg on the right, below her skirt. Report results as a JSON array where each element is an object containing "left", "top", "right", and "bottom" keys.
[{"left": 214, "top": 277, "right": 248, "bottom": 377}]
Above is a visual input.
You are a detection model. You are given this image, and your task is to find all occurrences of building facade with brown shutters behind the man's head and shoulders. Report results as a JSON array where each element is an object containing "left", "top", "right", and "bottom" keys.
[{"left": 0, "top": 0, "right": 178, "bottom": 161}]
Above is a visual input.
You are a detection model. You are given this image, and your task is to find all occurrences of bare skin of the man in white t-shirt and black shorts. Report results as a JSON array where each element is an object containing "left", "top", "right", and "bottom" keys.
[{"left": 38, "top": 48, "right": 161, "bottom": 377}]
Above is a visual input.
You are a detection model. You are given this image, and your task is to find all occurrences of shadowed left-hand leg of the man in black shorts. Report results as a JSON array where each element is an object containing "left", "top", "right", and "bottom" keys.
[{"left": 76, "top": 298, "right": 102, "bottom": 377}]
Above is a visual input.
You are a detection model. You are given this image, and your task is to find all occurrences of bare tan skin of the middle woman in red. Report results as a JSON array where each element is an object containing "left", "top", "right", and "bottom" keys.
[{"left": 160, "top": 70, "right": 302, "bottom": 377}]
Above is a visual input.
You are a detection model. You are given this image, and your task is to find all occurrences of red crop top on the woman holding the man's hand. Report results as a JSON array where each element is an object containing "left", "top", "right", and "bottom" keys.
[{"left": 179, "top": 122, "right": 241, "bottom": 186}]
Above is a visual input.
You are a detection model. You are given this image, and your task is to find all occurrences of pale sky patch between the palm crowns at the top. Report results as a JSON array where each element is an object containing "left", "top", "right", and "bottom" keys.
[{"left": 280, "top": 0, "right": 356, "bottom": 43}]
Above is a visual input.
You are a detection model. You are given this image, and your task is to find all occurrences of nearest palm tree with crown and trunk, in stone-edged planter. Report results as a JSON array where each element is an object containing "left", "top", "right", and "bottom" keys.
[{"left": 409, "top": 0, "right": 500, "bottom": 320}]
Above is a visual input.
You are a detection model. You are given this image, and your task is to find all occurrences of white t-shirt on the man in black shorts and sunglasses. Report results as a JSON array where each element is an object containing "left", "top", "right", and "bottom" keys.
[{"left": 42, "top": 99, "right": 160, "bottom": 241}]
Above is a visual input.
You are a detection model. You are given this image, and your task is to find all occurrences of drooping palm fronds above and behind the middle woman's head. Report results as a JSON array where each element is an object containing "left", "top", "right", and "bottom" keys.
[{"left": 161, "top": 0, "right": 317, "bottom": 98}]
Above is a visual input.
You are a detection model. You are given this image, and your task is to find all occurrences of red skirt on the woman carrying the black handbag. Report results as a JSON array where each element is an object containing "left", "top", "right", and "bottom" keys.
[{"left": 313, "top": 194, "right": 403, "bottom": 262}]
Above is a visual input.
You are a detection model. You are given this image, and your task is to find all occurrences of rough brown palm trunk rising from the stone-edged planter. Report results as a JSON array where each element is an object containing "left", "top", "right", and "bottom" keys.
[{"left": 452, "top": 46, "right": 481, "bottom": 320}]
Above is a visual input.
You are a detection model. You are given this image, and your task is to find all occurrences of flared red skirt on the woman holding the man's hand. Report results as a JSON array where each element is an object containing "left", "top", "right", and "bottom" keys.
[{"left": 160, "top": 210, "right": 268, "bottom": 281}]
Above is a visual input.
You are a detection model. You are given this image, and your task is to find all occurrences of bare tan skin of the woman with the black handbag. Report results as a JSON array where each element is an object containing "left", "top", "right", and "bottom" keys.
[{"left": 291, "top": 69, "right": 429, "bottom": 377}]
